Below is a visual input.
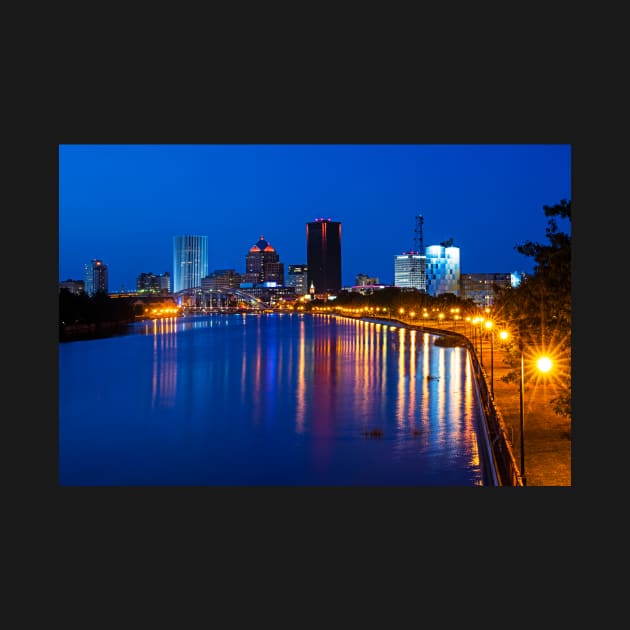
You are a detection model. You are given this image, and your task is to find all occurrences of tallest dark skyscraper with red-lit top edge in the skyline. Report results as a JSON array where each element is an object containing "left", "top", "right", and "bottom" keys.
[{"left": 306, "top": 219, "right": 341, "bottom": 293}]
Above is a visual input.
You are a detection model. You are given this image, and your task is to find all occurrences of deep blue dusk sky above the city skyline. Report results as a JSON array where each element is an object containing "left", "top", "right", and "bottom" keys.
[{"left": 59, "top": 144, "right": 571, "bottom": 292}]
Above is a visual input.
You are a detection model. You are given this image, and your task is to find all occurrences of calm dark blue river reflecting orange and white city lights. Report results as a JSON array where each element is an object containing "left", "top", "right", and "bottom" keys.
[{"left": 59, "top": 314, "right": 489, "bottom": 486}]
